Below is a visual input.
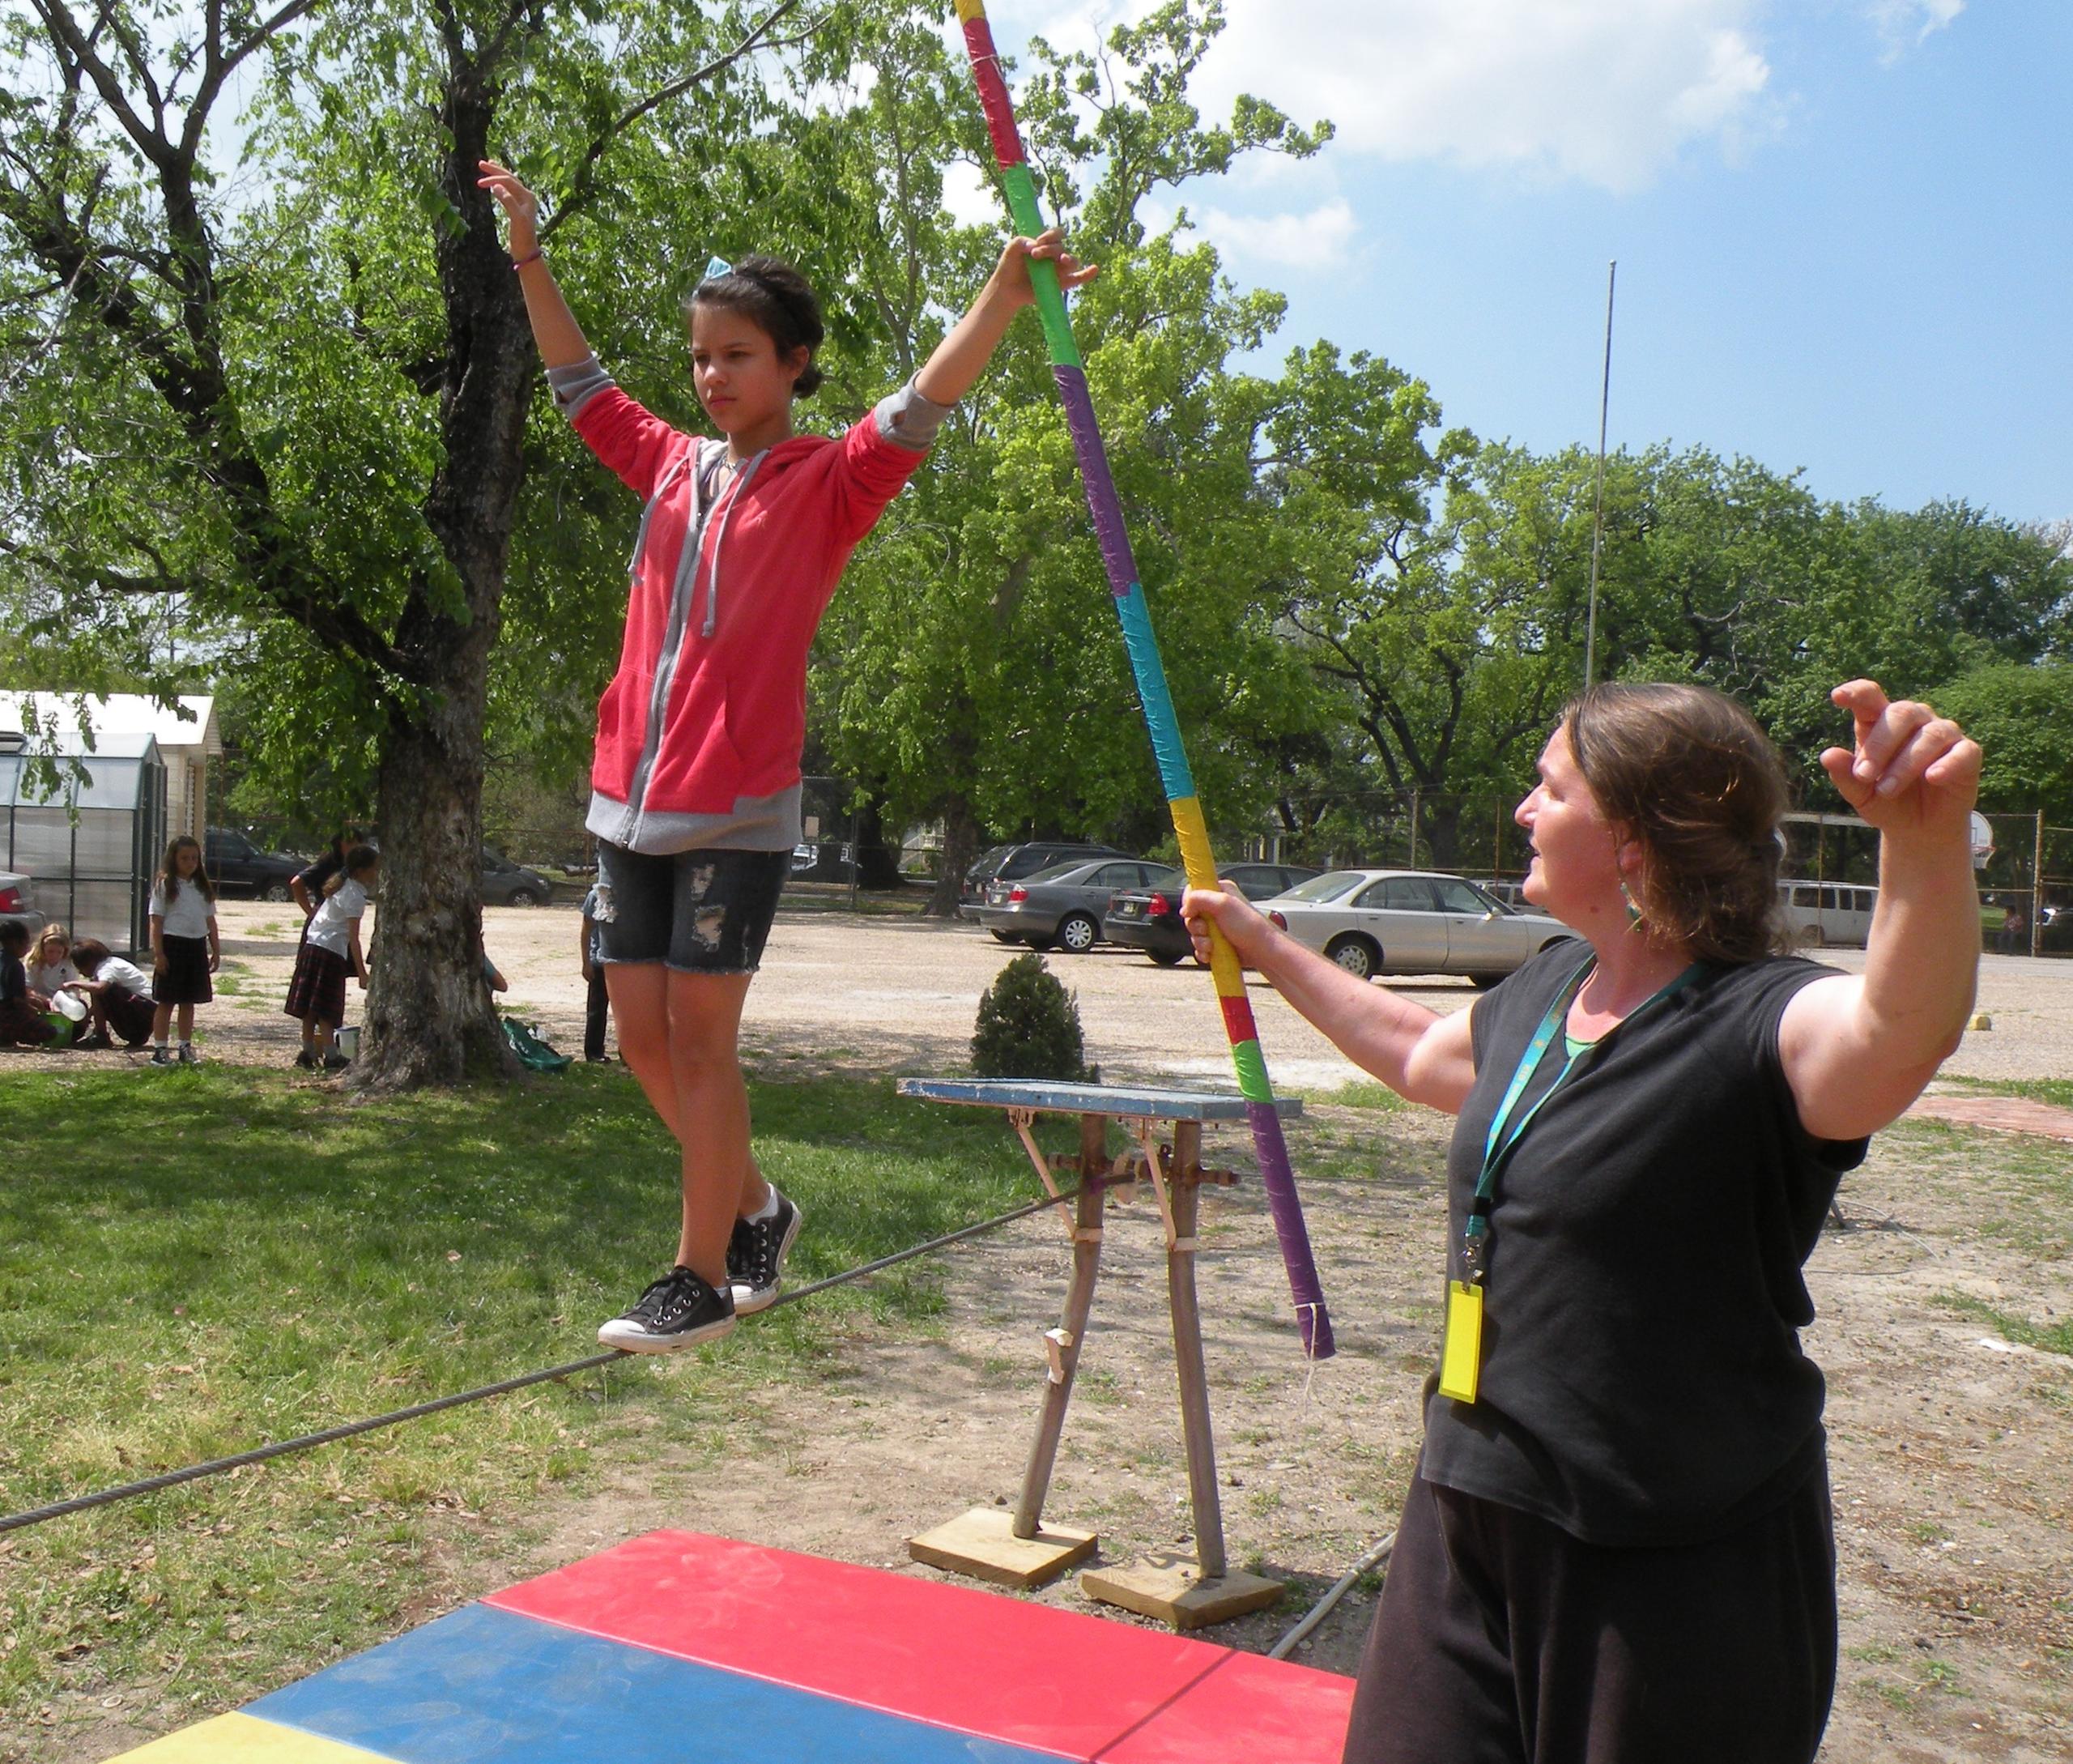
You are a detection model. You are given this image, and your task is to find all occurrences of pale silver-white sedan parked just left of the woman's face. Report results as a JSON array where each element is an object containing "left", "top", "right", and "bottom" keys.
[{"left": 1262, "top": 871, "right": 1576, "bottom": 986}]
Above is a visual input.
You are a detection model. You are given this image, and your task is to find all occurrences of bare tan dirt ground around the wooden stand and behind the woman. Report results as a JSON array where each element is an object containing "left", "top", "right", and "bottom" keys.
[{"left": 16, "top": 904, "right": 2073, "bottom": 1764}]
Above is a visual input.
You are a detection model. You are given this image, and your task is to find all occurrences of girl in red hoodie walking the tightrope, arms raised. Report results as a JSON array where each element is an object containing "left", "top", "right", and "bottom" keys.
[{"left": 481, "top": 160, "right": 1095, "bottom": 1353}]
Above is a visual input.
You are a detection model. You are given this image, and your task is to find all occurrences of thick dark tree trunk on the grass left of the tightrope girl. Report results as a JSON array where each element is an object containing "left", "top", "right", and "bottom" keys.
[{"left": 356, "top": 60, "right": 537, "bottom": 1090}]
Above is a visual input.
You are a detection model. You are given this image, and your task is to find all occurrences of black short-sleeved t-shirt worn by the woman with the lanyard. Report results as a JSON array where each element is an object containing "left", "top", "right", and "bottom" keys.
[{"left": 1422, "top": 944, "right": 1868, "bottom": 1545}]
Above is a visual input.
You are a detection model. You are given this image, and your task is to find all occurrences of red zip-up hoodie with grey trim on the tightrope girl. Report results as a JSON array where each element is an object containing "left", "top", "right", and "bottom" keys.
[{"left": 549, "top": 363, "right": 943, "bottom": 852}]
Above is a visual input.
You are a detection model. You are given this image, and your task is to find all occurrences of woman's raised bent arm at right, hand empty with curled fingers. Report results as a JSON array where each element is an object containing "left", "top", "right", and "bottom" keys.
[{"left": 1778, "top": 680, "right": 1980, "bottom": 1140}]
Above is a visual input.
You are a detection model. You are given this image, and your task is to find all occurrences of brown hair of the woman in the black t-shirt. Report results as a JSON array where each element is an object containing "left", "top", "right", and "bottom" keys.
[{"left": 1561, "top": 684, "right": 1789, "bottom": 962}]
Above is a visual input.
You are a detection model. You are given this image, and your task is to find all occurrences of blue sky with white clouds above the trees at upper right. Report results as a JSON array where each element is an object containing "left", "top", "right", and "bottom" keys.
[{"left": 974, "top": 0, "right": 2073, "bottom": 520}]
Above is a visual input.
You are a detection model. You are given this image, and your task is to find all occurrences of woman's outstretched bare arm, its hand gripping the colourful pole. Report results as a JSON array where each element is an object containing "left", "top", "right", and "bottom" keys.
[{"left": 1181, "top": 885, "right": 1476, "bottom": 1115}]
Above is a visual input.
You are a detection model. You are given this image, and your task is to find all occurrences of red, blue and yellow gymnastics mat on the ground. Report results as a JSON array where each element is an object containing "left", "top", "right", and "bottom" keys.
[{"left": 109, "top": 1532, "right": 1354, "bottom": 1764}]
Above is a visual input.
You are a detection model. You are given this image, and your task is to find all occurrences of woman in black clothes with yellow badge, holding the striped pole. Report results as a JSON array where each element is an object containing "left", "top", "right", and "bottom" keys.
[{"left": 1184, "top": 680, "right": 1980, "bottom": 1764}]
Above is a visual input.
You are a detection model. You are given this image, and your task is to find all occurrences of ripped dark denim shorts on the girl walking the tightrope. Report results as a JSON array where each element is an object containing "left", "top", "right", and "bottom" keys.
[{"left": 597, "top": 840, "right": 792, "bottom": 974}]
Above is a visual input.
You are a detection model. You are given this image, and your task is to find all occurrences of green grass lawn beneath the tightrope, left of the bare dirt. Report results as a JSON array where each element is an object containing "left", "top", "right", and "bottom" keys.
[{"left": 0, "top": 1066, "right": 1070, "bottom": 1760}]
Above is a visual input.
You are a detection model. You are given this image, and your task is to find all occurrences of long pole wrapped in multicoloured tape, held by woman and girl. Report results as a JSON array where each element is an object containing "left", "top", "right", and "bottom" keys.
[{"left": 956, "top": 0, "right": 1333, "bottom": 1360}]
